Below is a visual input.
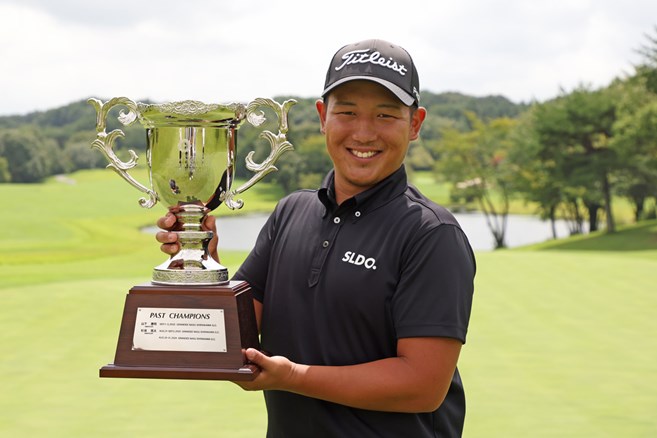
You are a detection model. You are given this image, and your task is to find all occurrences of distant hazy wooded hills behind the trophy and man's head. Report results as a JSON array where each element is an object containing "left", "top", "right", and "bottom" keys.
[{"left": 0, "top": 92, "right": 526, "bottom": 188}]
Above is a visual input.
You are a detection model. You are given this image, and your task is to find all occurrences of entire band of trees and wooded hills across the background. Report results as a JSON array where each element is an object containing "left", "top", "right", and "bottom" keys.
[{"left": 0, "top": 33, "right": 657, "bottom": 248}]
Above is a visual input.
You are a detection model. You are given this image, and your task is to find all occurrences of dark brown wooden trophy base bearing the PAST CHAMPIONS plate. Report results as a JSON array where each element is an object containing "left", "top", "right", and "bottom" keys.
[{"left": 100, "top": 281, "right": 260, "bottom": 381}]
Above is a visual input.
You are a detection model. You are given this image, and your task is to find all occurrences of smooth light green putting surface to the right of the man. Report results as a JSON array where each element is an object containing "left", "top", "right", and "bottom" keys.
[{"left": 460, "top": 250, "right": 657, "bottom": 437}]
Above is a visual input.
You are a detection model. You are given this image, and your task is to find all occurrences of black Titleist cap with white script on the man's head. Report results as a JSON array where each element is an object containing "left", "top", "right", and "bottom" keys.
[{"left": 322, "top": 40, "right": 420, "bottom": 106}]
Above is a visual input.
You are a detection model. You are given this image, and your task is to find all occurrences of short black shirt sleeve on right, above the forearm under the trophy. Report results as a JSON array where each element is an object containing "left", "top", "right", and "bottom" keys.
[{"left": 392, "top": 224, "right": 476, "bottom": 343}]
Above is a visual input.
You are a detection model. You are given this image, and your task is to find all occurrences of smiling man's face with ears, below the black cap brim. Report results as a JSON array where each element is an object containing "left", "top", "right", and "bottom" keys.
[{"left": 317, "top": 81, "right": 426, "bottom": 203}]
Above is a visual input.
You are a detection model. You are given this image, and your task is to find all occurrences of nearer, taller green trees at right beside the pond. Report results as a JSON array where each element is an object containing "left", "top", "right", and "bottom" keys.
[{"left": 432, "top": 31, "right": 657, "bottom": 248}]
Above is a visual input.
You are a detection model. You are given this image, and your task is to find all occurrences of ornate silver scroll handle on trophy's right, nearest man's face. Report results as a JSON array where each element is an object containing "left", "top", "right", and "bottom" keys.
[{"left": 224, "top": 98, "right": 297, "bottom": 210}]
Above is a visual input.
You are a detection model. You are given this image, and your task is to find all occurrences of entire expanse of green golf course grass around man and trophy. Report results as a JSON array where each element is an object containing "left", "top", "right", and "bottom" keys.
[{"left": 0, "top": 171, "right": 657, "bottom": 437}]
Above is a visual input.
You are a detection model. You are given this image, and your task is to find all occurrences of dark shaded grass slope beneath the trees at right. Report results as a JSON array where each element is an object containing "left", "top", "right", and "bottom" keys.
[{"left": 531, "top": 220, "right": 657, "bottom": 251}]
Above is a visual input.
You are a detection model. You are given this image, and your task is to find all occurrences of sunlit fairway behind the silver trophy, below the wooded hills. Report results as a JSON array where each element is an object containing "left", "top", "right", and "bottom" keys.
[{"left": 0, "top": 170, "right": 281, "bottom": 266}]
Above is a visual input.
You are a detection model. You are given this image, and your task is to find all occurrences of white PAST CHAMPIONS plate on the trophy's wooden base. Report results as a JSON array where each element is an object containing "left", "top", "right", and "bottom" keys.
[{"left": 132, "top": 307, "right": 227, "bottom": 353}]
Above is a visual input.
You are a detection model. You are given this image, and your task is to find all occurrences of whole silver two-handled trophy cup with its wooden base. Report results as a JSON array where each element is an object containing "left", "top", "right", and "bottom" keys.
[{"left": 88, "top": 97, "right": 296, "bottom": 381}]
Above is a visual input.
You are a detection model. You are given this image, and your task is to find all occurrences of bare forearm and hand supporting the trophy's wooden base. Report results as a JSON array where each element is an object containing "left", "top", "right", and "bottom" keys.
[{"left": 240, "top": 338, "right": 461, "bottom": 412}]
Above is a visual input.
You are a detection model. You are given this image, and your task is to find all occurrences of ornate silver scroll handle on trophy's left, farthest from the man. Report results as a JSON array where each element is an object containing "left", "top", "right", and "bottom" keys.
[{"left": 87, "top": 97, "right": 157, "bottom": 208}]
